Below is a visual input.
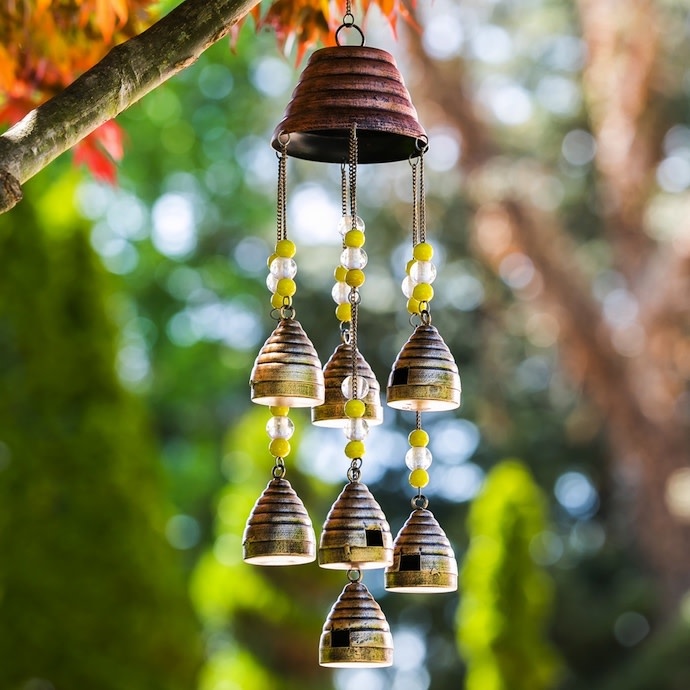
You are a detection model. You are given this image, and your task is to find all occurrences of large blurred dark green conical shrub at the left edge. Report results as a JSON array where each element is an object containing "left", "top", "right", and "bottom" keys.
[{"left": 0, "top": 202, "right": 201, "bottom": 690}]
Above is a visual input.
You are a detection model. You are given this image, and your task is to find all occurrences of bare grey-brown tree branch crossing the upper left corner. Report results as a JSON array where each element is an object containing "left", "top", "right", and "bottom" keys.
[{"left": 0, "top": 0, "right": 260, "bottom": 213}]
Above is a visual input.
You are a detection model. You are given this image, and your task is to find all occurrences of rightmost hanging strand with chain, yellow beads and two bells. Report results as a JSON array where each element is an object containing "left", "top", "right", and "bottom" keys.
[{"left": 385, "top": 146, "right": 460, "bottom": 593}]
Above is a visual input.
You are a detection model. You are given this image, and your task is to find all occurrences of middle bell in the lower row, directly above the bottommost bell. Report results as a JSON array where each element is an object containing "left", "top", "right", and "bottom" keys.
[{"left": 319, "top": 482, "right": 393, "bottom": 570}]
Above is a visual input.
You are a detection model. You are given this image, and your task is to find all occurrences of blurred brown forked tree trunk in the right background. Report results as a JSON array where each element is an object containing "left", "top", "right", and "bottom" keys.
[{"left": 409, "top": 0, "right": 690, "bottom": 612}]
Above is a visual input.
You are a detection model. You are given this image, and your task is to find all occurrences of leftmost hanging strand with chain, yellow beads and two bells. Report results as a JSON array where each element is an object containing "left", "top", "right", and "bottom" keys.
[{"left": 242, "top": 137, "right": 324, "bottom": 565}]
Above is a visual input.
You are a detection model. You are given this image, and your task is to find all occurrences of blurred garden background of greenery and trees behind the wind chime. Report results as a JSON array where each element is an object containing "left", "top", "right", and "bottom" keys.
[{"left": 0, "top": 0, "right": 690, "bottom": 690}]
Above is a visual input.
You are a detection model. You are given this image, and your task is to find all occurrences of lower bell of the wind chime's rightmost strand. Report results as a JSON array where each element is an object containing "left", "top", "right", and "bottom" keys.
[{"left": 385, "top": 508, "right": 458, "bottom": 594}]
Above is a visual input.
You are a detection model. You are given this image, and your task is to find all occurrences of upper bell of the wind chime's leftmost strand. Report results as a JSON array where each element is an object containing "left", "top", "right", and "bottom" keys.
[{"left": 249, "top": 319, "right": 324, "bottom": 407}]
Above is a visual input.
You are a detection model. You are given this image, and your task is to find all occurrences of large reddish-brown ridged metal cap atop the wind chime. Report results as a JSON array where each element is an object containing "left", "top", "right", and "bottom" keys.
[{"left": 272, "top": 46, "right": 426, "bottom": 163}]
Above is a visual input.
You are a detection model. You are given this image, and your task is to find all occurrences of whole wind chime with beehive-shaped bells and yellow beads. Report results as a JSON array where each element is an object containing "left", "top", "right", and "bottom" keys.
[{"left": 243, "top": 5, "right": 460, "bottom": 668}]
